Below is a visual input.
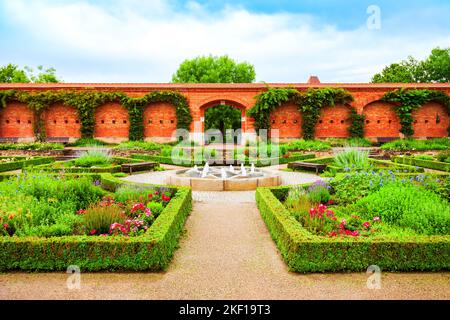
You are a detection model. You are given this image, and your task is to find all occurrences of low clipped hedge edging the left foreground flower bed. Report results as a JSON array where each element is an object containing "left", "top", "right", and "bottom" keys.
[{"left": 0, "top": 175, "right": 192, "bottom": 271}]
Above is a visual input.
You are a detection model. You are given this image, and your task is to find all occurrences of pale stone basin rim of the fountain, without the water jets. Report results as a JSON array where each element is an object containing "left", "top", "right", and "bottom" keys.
[{"left": 166, "top": 169, "right": 281, "bottom": 191}]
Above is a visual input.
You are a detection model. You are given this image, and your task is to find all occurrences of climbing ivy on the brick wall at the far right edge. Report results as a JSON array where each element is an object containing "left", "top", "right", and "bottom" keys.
[{"left": 381, "top": 88, "right": 450, "bottom": 137}]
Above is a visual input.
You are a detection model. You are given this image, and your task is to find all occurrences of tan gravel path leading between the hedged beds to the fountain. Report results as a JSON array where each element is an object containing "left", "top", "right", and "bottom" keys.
[{"left": 0, "top": 168, "right": 450, "bottom": 299}]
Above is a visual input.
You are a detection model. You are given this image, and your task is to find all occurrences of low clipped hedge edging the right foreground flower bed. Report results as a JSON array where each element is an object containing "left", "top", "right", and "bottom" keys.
[{"left": 256, "top": 188, "right": 450, "bottom": 273}]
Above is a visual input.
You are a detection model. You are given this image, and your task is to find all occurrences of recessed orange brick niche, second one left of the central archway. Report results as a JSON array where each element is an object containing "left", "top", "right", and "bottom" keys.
[{"left": 94, "top": 102, "right": 130, "bottom": 142}]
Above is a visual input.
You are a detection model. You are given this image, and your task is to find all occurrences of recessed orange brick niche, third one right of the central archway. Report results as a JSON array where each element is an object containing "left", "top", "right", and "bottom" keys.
[{"left": 363, "top": 101, "right": 401, "bottom": 138}]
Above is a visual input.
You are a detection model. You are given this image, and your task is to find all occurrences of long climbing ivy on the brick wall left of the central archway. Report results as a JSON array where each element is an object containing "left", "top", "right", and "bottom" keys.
[{"left": 0, "top": 90, "right": 192, "bottom": 141}]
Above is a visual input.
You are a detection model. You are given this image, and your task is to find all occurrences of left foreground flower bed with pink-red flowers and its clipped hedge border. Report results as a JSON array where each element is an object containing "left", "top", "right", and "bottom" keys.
[{"left": 0, "top": 174, "right": 192, "bottom": 271}]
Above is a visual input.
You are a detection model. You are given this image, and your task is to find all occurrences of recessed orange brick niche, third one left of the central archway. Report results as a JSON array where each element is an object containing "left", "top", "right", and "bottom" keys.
[{"left": 43, "top": 103, "right": 81, "bottom": 138}]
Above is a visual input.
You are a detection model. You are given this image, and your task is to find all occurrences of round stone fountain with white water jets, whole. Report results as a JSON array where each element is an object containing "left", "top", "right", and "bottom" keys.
[{"left": 166, "top": 163, "right": 281, "bottom": 191}]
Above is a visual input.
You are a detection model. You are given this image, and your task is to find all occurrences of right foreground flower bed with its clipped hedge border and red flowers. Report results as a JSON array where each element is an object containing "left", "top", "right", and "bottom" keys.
[{"left": 256, "top": 172, "right": 450, "bottom": 272}]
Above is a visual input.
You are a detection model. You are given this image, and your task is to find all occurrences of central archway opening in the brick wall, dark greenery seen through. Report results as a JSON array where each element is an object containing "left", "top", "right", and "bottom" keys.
[{"left": 204, "top": 104, "right": 242, "bottom": 144}]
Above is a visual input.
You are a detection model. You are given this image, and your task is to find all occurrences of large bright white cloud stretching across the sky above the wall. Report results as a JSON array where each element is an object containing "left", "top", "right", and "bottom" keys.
[{"left": 0, "top": 0, "right": 450, "bottom": 82}]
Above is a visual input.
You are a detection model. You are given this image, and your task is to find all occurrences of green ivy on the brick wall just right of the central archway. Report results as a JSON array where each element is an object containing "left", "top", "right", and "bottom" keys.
[{"left": 247, "top": 88, "right": 353, "bottom": 139}]
